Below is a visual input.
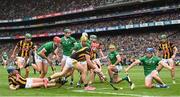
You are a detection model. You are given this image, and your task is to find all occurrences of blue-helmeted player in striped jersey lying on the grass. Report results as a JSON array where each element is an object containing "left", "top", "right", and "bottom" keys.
[{"left": 7, "top": 66, "right": 60, "bottom": 90}]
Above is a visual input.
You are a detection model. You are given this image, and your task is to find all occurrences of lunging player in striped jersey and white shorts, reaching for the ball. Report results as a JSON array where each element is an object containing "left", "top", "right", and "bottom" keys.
[{"left": 48, "top": 37, "right": 104, "bottom": 90}]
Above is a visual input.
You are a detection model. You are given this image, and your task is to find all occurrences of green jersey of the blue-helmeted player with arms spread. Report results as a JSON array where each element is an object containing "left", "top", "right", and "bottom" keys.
[{"left": 139, "top": 56, "right": 161, "bottom": 76}]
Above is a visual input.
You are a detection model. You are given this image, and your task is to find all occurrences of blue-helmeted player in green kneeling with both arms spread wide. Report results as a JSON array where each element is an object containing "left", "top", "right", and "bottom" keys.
[{"left": 125, "top": 48, "right": 172, "bottom": 88}]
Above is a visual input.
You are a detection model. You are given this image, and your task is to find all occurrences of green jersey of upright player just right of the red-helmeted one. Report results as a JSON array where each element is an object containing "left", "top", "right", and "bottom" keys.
[{"left": 61, "top": 37, "right": 76, "bottom": 56}]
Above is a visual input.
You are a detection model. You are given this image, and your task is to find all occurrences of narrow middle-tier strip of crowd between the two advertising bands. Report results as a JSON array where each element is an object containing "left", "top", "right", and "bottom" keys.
[{"left": 0, "top": 12, "right": 180, "bottom": 37}]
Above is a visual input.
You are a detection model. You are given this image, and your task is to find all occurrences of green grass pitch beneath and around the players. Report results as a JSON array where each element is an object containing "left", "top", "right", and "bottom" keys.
[{"left": 0, "top": 66, "right": 180, "bottom": 97}]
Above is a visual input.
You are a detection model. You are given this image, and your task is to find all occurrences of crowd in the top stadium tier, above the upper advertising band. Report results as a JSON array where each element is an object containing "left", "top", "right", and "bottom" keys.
[{"left": 0, "top": 0, "right": 136, "bottom": 20}]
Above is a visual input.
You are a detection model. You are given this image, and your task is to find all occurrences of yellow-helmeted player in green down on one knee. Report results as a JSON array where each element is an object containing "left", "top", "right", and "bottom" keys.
[{"left": 108, "top": 44, "right": 135, "bottom": 89}]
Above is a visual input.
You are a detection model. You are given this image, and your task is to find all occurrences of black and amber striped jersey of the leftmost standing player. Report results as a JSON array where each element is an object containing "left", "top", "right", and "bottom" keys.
[{"left": 17, "top": 40, "right": 33, "bottom": 57}]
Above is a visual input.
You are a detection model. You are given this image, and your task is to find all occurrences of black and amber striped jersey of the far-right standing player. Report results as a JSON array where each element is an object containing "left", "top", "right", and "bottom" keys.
[{"left": 159, "top": 41, "right": 174, "bottom": 59}]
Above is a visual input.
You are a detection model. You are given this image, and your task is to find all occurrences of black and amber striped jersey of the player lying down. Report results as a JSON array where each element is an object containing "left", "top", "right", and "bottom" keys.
[{"left": 8, "top": 75, "right": 26, "bottom": 88}]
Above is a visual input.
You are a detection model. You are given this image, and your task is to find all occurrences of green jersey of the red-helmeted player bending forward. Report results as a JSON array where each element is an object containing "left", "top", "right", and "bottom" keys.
[{"left": 37, "top": 41, "right": 57, "bottom": 56}]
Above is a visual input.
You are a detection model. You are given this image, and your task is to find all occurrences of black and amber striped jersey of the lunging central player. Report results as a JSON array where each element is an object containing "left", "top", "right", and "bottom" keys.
[{"left": 71, "top": 47, "right": 90, "bottom": 61}]
